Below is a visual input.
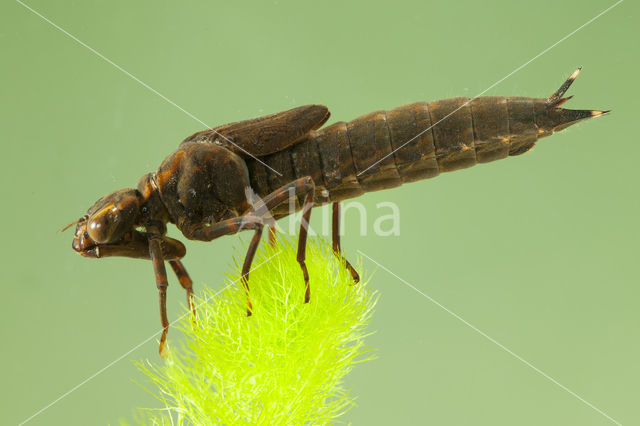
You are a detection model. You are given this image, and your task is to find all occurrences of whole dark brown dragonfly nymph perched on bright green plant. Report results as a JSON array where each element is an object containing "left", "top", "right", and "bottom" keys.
[{"left": 66, "top": 69, "right": 608, "bottom": 354}]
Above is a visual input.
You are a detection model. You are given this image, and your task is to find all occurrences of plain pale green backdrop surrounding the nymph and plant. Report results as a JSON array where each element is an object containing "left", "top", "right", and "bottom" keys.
[{"left": 0, "top": 0, "right": 640, "bottom": 425}]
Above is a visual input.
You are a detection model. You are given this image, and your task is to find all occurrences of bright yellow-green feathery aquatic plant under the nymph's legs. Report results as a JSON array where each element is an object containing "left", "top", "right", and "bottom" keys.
[{"left": 134, "top": 240, "right": 377, "bottom": 425}]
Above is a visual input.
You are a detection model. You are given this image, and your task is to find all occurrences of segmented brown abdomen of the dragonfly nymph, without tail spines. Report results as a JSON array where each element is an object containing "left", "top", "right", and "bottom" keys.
[{"left": 247, "top": 97, "right": 538, "bottom": 207}]
